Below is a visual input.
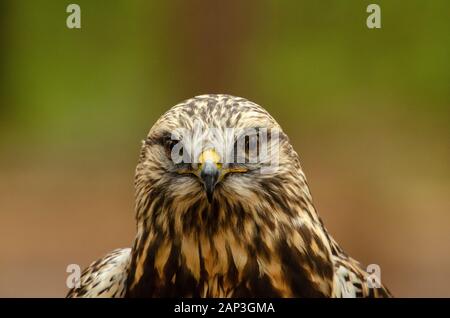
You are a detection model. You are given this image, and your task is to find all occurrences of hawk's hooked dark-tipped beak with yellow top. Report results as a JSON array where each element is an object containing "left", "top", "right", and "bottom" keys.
[{"left": 199, "top": 150, "right": 221, "bottom": 203}]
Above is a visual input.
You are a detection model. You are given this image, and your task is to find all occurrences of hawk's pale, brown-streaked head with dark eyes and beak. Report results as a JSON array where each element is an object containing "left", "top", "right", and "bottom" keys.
[{"left": 135, "top": 95, "right": 299, "bottom": 234}]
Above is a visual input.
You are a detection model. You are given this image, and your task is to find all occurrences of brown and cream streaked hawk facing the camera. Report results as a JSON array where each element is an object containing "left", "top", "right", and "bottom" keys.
[{"left": 67, "top": 94, "right": 391, "bottom": 297}]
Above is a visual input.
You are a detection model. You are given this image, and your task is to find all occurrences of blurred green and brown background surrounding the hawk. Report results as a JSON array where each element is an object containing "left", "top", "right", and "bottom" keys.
[{"left": 0, "top": 0, "right": 450, "bottom": 297}]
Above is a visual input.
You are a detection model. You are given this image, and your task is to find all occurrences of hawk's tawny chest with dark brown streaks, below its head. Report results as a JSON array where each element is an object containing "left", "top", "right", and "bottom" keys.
[{"left": 128, "top": 229, "right": 328, "bottom": 297}]
